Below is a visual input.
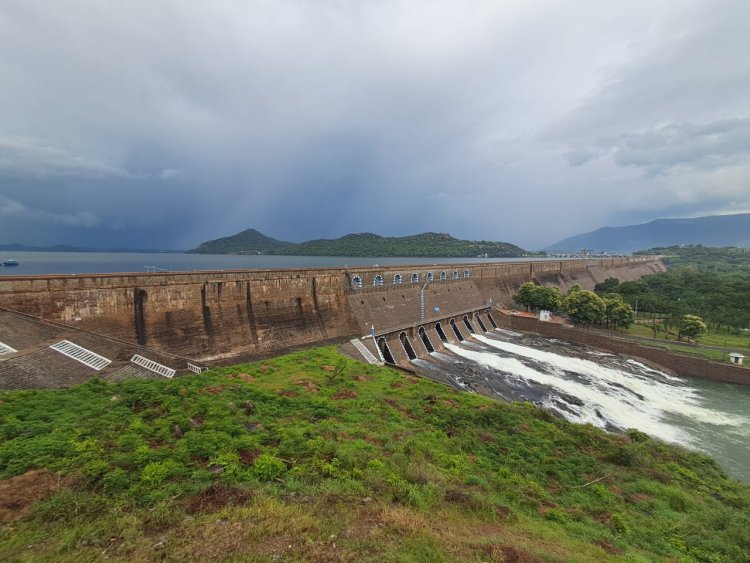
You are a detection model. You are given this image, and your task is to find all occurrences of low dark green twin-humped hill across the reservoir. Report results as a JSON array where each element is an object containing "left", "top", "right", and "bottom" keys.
[{"left": 191, "top": 229, "right": 527, "bottom": 258}]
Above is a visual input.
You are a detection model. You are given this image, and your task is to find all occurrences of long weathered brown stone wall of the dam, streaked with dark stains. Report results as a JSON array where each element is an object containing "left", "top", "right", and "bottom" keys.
[{"left": 0, "top": 257, "right": 664, "bottom": 361}]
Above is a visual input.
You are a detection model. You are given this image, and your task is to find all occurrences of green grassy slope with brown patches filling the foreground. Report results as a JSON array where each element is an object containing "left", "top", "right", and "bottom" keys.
[{"left": 0, "top": 348, "right": 750, "bottom": 562}]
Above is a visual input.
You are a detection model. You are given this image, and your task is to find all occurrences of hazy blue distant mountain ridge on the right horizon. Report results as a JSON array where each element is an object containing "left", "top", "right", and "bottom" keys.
[{"left": 544, "top": 213, "right": 750, "bottom": 254}]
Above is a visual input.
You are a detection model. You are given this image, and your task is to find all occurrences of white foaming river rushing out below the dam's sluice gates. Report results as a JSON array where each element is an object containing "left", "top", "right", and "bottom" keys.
[{"left": 414, "top": 329, "right": 750, "bottom": 483}]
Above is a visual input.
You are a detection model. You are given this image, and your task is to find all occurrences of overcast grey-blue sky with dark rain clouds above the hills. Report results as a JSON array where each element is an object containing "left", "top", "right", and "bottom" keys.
[{"left": 0, "top": 0, "right": 750, "bottom": 249}]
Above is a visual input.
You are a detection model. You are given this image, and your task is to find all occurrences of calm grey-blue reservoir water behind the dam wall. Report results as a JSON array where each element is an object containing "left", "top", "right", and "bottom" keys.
[{"left": 0, "top": 252, "right": 559, "bottom": 276}]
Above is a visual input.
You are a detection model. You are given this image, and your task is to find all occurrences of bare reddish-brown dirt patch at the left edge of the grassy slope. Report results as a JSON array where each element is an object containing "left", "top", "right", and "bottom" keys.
[{"left": 0, "top": 469, "right": 70, "bottom": 524}]
